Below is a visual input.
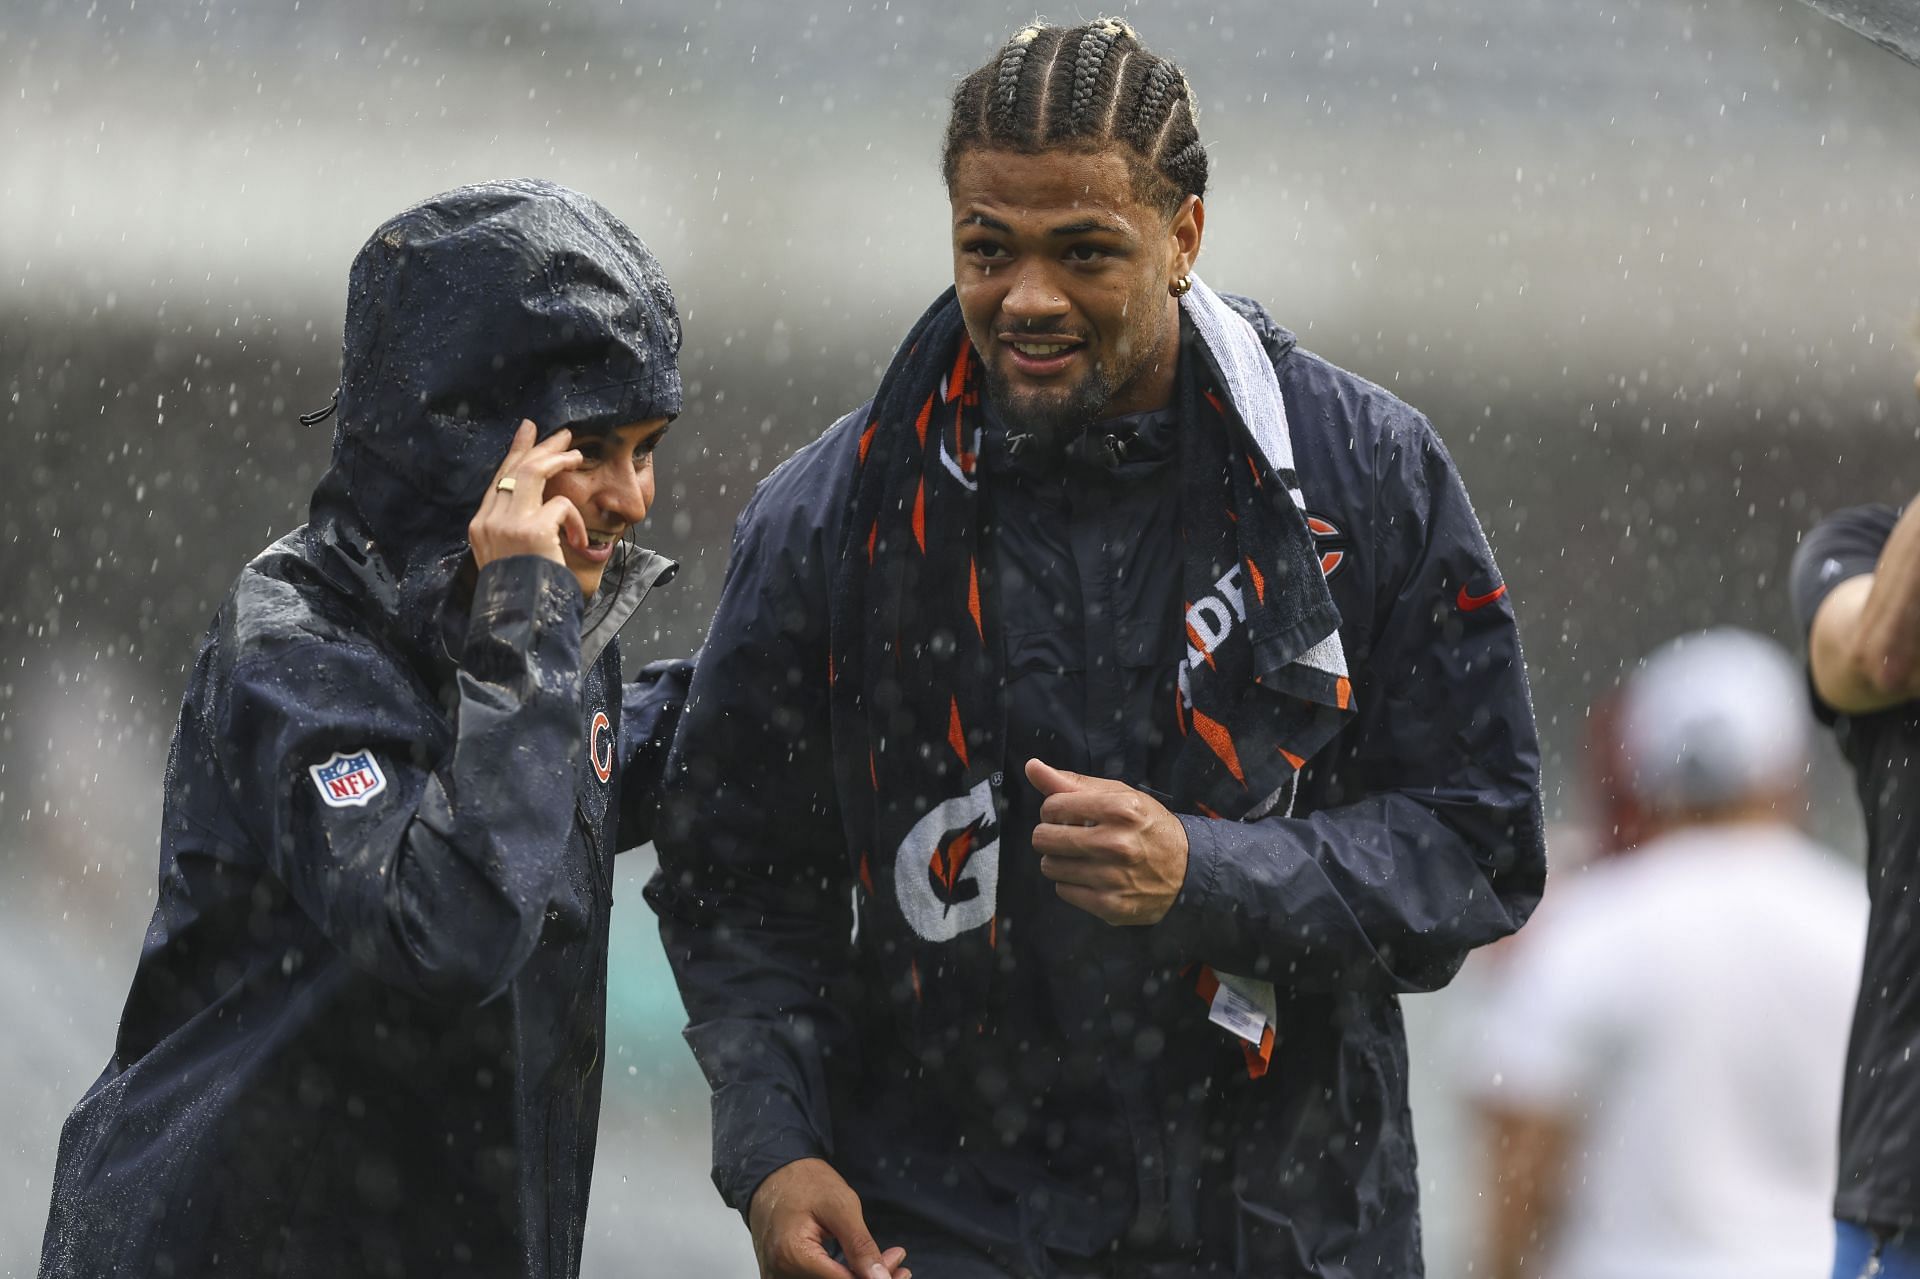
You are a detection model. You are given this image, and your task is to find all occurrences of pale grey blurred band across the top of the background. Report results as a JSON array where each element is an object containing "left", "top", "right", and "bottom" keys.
[{"left": 11, "top": 0, "right": 1920, "bottom": 380}]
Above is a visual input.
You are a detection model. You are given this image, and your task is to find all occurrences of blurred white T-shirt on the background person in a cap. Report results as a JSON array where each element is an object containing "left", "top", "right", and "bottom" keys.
[{"left": 1476, "top": 824, "right": 1866, "bottom": 1279}]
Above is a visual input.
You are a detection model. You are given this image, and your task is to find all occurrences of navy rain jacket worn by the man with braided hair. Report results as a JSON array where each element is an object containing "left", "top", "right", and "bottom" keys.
[{"left": 649, "top": 293, "right": 1544, "bottom": 1279}]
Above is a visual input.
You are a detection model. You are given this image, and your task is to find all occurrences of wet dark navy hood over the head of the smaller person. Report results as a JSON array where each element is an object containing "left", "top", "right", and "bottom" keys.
[{"left": 309, "top": 179, "right": 680, "bottom": 647}]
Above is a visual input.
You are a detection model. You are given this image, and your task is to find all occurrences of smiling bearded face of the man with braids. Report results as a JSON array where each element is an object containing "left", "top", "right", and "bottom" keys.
[{"left": 948, "top": 146, "right": 1206, "bottom": 444}]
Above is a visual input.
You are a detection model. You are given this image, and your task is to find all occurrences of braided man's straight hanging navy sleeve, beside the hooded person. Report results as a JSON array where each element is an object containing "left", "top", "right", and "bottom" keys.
[{"left": 647, "top": 455, "right": 852, "bottom": 1214}]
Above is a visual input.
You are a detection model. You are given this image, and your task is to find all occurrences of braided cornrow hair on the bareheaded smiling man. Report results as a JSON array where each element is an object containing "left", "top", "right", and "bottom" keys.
[{"left": 941, "top": 17, "right": 1208, "bottom": 217}]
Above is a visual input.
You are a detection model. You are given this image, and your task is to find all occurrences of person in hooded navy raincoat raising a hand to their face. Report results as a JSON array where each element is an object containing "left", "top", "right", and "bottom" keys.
[{"left": 40, "top": 181, "right": 682, "bottom": 1279}]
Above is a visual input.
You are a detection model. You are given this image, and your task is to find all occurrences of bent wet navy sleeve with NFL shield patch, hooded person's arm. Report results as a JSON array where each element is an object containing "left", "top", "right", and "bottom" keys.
[{"left": 219, "top": 557, "right": 580, "bottom": 1002}]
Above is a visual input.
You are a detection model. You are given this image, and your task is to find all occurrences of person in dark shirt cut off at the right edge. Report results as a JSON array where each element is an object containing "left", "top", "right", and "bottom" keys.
[{"left": 1791, "top": 351, "right": 1920, "bottom": 1279}]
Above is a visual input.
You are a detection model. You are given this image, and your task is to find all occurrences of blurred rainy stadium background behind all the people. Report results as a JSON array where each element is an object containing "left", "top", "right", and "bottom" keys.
[{"left": 0, "top": 0, "right": 1920, "bottom": 1279}]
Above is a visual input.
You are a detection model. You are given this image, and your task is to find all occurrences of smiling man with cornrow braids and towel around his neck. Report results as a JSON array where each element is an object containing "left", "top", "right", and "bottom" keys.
[{"left": 649, "top": 19, "right": 1544, "bottom": 1279}]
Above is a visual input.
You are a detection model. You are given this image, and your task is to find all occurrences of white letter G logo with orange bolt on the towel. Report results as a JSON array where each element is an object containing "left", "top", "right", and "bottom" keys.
[{"left": 893, "top": 778, "right": 1000, "bottom": 941}]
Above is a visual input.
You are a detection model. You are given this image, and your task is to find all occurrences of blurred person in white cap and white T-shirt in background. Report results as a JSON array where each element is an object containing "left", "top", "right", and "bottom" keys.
[{"left": 1475, "top": 630, "right": 1864, "bottom": 1279}]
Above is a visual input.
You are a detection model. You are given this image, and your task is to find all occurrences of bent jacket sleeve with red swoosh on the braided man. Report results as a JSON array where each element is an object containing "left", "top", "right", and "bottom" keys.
[{"left": 1156, "top": 413, "right": 1546, "bottom": 991}]
